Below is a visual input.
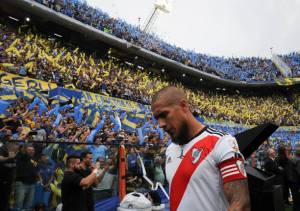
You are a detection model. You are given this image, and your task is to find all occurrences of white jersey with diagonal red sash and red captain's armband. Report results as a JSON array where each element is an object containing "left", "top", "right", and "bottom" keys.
[{"left": 166, "top": 128, "right": 246, "bottom": 211}]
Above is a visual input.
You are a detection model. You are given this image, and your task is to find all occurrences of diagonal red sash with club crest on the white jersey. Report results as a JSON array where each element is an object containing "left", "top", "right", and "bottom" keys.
[{"left": 170, "top": 135, "right": 219, "bottom": 211}]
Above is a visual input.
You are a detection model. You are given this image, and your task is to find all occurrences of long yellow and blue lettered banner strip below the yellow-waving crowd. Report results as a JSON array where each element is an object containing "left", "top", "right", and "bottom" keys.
[{"left": 0, "top": 70, "right": 150, "bottom": 112}]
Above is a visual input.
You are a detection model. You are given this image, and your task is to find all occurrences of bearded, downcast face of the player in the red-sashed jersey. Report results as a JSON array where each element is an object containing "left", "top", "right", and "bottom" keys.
[{"left": 151, "top": 98, "right": 188, "bottom": 145}]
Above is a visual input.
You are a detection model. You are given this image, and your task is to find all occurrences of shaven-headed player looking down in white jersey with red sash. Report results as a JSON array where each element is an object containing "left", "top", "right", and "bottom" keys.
[{"left": 151, "top": 86, "right": 250, "bottom": 211}]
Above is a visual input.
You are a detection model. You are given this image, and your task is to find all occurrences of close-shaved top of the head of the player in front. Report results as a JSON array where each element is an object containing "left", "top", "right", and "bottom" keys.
[{"left": 152, "top": 86, "right": 187, "bottom": 105}]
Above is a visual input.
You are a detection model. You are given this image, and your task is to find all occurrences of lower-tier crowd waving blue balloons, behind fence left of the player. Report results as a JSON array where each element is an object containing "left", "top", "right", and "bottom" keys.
[{"left": 0, "top": 97, "right": 169, "bottom": 210}]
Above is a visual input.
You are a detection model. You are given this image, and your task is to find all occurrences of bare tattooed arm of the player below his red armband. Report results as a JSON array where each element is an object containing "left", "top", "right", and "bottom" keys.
[{"left": 224, "top": 179, "right": 250, "bottom": 211}]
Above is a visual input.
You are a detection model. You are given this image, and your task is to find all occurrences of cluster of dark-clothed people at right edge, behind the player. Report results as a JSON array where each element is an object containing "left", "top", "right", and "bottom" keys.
[{"left": 254, "top": 141, "right": 300, "bottom": 211}]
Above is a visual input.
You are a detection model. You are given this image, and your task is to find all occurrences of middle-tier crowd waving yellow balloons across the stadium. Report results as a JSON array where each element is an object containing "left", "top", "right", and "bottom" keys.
[{"left": 0, "top": 24, "right": 300, "bottom": 126}]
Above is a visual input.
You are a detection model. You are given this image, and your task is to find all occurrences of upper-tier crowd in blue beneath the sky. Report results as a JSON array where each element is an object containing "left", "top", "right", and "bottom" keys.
[{"left": 31, "top": 0, "right": 300, "bottom": 81}]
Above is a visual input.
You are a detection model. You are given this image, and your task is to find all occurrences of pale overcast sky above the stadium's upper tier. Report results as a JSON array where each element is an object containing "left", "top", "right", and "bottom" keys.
[{"left": 87, "top": 0, "right": 300, "bottom": 57}]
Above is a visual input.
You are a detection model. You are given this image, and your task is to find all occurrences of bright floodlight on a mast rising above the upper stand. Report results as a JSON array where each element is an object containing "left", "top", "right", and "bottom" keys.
[{"left": 143, "top": 0, "right": 172, "bottom": 33}]
